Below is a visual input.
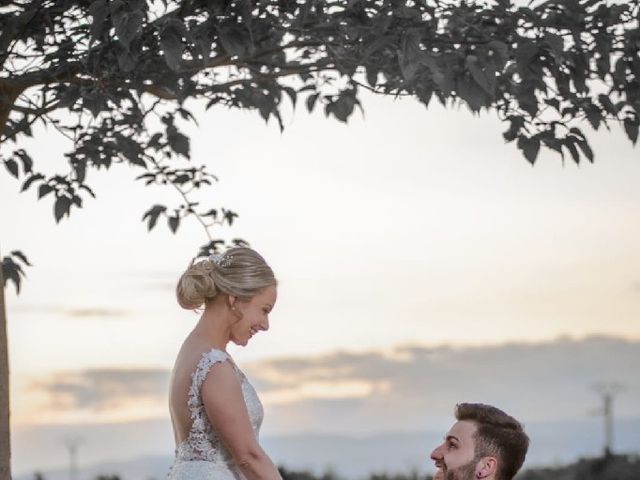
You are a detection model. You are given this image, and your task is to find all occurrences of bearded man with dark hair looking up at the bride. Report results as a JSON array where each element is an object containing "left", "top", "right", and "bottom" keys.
[{"left": 431, "top": 403, "right": 529, "bottom": 480}]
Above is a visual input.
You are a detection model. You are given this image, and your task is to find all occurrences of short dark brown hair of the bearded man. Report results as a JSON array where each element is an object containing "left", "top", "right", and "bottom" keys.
[{"left": 455, "top": 403, "right": 529, "bottom": 480}]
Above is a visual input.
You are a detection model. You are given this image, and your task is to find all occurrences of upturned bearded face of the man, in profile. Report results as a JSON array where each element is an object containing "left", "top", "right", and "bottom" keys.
[{"left": 431, "top": 420, "right": 477, "bottom": 480}]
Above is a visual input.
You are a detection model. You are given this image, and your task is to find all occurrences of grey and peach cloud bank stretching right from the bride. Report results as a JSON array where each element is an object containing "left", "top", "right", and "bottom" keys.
[{"left": 247, "top": 337, "right": 640, "bottom": 433}]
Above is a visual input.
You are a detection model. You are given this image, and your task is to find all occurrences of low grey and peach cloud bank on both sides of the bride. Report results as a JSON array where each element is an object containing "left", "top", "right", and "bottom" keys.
[{"left": 22, "top": 337, "right": 640, "bottom": 435}]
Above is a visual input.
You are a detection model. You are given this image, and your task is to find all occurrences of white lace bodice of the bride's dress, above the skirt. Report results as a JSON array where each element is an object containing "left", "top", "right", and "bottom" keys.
[{"left": 176, "top": 349, "right": 264, "bottom": 464}]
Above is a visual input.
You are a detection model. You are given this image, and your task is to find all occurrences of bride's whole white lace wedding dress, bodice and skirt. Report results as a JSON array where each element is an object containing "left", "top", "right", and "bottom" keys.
[{"left": 167, "top": 349, "right": 264, "bottom": 480}]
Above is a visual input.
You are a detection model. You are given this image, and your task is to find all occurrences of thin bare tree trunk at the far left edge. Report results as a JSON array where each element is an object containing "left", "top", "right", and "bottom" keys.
[{"left": 0, "top": 248, "right": 11, "bottom": 480}]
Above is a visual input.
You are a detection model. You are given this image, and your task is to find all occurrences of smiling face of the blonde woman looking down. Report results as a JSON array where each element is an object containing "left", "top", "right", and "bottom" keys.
[{"left": 231, "top": 286, "right": 277, "bottom": 346}]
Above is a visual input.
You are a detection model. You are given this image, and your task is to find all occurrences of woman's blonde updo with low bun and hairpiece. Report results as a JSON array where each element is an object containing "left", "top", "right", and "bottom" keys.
[{"left": 176, "top": 247, "right": 278, "bottom": 310}]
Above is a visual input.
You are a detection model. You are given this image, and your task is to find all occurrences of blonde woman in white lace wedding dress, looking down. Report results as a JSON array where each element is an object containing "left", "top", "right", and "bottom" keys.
[{"left": 167, "top": 247, "right": 281, "bottom": 480}]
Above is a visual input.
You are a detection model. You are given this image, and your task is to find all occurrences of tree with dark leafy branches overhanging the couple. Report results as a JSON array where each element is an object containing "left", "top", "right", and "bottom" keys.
[{"left": 0, "top": 0, "right": 640, "bottom": 480}]
